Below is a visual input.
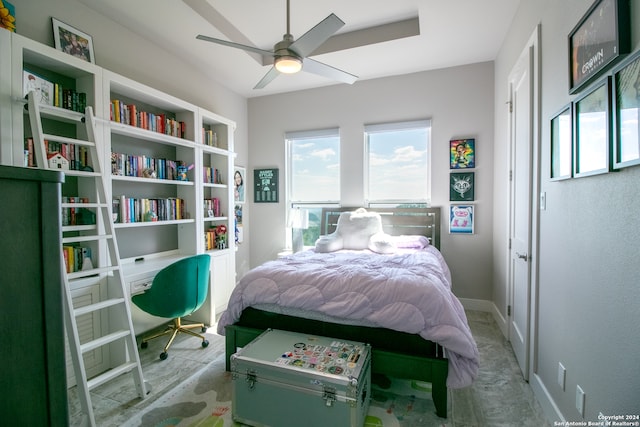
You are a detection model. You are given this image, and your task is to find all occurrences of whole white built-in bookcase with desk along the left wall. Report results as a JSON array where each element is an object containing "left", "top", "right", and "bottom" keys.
[{"left": 0, "top": 30, "right": 235, "bottom": 380}]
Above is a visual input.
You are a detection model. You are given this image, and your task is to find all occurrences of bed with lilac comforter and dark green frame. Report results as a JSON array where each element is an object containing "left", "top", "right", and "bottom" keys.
[{"left": 218, "top": 207, "right": 478, "bottom": 418}]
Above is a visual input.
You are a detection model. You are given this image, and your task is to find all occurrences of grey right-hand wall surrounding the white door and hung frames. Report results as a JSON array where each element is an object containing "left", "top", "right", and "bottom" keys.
[{"left": 493, "top": 0, "right": 640, "bottom": 421}]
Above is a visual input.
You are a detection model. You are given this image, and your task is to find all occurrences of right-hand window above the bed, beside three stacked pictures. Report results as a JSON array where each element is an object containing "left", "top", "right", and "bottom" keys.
[{"left": 365, "top": 120, "right": 431, "bottom": 206}]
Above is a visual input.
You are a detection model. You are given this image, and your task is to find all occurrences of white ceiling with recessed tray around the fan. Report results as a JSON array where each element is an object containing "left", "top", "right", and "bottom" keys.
[{"left": 79, "top": 0, "right": 520, "bottom": 98}]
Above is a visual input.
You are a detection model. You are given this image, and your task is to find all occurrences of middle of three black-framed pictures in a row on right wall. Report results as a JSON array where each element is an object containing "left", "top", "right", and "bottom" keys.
[{"left": 573, "top": 76, "right": 612, "bottom": 178}]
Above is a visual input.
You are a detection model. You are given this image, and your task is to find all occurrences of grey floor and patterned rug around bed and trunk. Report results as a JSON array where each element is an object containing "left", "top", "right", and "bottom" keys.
[{"left": 69, "top": 311, "right": 549, "bottom": 427}]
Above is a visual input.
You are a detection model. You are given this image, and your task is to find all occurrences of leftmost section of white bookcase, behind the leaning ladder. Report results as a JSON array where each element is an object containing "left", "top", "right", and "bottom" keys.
[{"left": 8, "top": 31, "right": 112, "bottom": 385}]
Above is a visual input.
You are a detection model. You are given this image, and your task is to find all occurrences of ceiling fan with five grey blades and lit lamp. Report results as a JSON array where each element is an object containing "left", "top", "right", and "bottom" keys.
[{"left": 196, "top": 0, "right": 358, "bottom": 89}]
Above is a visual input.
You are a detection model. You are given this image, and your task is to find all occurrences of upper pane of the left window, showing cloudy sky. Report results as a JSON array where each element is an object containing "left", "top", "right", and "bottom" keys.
[{"left": 289, "top": 136, "right": 340, "bottom": 202}]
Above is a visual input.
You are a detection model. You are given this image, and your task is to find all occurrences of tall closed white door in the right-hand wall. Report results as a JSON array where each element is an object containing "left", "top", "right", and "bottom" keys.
[{"left": 509, "top": 37, "right": 535, "bottom": 380}]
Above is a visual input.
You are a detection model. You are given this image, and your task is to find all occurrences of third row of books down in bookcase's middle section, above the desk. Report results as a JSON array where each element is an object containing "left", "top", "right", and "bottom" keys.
[{"left": 112, "top": 196, "right": 187, "bottom": 223}]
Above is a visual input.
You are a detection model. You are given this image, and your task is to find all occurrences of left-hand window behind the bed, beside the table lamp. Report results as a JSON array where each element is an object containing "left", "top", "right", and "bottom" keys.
[{"left": 285, "top": 128, "right": 340, "bottom": 246}]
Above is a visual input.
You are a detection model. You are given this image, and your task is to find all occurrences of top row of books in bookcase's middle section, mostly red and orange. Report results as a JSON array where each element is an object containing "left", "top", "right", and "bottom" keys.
[{"left": 111, "top": 99, "right": 187, "bottom": 138}]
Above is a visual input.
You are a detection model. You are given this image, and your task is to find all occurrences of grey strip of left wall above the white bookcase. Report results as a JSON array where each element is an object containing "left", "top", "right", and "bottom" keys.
[{"left": 12, "top": 0, "right": 249, "bottom": 276}]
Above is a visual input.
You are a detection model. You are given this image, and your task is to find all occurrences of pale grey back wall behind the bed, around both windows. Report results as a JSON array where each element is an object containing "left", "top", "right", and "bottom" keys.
[{"left": 247, "top": 62, "right": 494, "bottom": 300}]
